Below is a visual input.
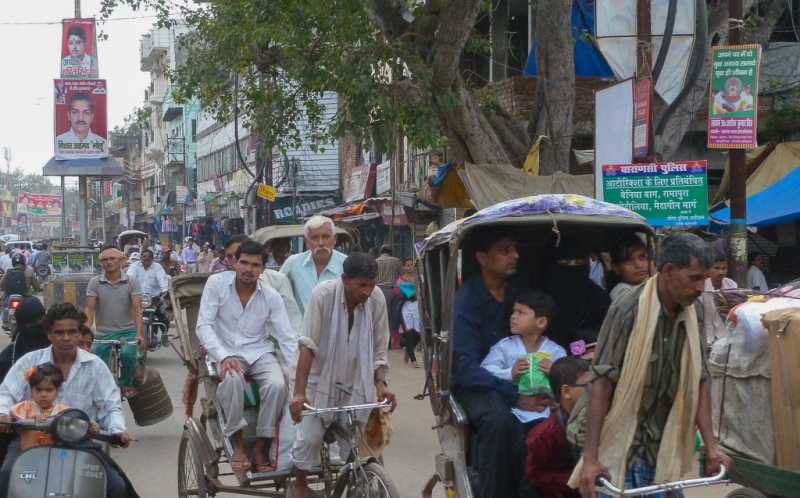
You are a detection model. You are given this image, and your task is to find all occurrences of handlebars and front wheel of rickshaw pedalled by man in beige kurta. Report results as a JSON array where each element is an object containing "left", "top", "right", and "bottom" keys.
[{"left": 303, "top": 394, "right": 400, "bottom": 498}]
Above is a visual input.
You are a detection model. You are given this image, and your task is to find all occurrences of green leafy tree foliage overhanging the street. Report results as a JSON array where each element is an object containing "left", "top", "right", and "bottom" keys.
[{"left": 101, "top": 0, "right": 446, "bottom": 156}]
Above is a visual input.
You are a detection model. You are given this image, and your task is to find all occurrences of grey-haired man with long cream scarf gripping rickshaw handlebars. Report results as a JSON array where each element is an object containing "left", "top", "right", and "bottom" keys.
[{"left": 567, "top": 232, "right": 732, "bottom": 498}]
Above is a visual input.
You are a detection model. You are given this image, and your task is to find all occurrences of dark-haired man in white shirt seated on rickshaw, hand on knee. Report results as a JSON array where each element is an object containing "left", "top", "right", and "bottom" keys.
[{"left": 196, "top": 239, "right": 298, "bottom": 473}]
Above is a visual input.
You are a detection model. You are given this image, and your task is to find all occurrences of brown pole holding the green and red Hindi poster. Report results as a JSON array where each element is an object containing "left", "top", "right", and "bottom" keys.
[{"left": 728, "top": 0, "right": 747, "bottom": 287}]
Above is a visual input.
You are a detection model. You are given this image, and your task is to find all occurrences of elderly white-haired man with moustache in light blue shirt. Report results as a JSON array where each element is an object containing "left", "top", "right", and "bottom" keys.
[{"left": 281, "top": 216, "right": 347, "bottom": 313}]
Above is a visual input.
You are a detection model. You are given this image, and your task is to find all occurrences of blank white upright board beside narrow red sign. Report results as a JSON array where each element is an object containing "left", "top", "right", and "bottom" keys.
[{"left": 593, "top": 80, "right": 633, "bottom": 201}]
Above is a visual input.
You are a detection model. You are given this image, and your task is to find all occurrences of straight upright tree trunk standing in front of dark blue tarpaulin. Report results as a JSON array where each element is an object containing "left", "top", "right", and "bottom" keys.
[{"left": 531, "top": 0, "right": 575, "bottom": 175}]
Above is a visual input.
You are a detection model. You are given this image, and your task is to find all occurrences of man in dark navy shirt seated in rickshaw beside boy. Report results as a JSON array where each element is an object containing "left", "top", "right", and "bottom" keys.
[{"left": 452, "top": 226, "right": 548, "bottom": 498}]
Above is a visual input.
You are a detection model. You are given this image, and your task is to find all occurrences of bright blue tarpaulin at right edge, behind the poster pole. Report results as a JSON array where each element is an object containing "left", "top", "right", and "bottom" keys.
[{"left": 711, "top": 166, "right": 800, "bottom": 227}]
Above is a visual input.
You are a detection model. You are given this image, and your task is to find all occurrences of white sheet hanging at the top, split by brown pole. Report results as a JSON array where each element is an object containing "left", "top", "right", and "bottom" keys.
[{"left": 595, "top": 0, "right": 695, "bottom": 103}]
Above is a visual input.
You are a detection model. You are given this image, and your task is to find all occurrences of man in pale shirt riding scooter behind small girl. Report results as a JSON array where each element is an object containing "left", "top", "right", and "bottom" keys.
[{"left": 0, "top": 303, "right": 138, "bottom": 498}]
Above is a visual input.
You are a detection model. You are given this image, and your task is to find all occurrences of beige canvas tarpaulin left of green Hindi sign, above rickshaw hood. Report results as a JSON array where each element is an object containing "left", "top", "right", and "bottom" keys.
[{"left": 458, "top": 163, "right": 594, "bottom": 209}]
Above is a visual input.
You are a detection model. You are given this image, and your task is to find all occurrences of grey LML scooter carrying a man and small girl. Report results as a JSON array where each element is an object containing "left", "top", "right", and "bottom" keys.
[{"left": 4, "top": 408, "right": 122, "bottom": 498}]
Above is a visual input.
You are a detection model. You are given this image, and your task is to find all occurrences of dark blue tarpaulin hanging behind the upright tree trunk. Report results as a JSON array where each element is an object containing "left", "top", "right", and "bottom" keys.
[{"left": 525, "top": 0, "right": 614, "bottom": 77}]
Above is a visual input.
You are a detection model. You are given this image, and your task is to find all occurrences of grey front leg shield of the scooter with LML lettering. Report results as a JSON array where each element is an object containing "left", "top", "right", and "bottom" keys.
[{"left": 8, "top": 446, "right": 106, "bottom": 498}]
